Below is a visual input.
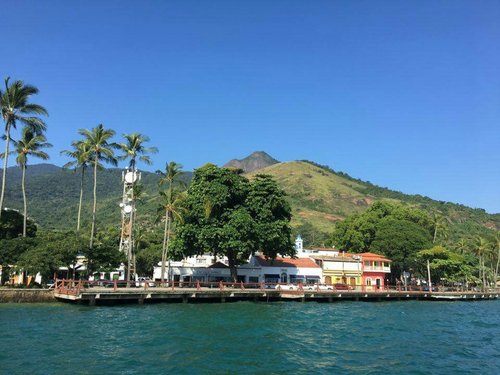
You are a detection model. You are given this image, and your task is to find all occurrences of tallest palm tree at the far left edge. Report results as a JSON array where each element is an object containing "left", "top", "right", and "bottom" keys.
[{"left": 0, "top": 77, "right": 48, "bottom": 217}]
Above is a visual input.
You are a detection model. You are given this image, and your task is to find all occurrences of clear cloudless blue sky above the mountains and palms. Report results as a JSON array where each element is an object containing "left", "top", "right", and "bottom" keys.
[{"left": 0, "top": 0, "right": 500, "bottom": 212}]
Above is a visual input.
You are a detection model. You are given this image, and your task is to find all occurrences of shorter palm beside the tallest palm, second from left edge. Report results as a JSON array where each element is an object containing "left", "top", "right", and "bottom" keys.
[{"left": 2, "top": 127, "right": 52, "bottom": 237}]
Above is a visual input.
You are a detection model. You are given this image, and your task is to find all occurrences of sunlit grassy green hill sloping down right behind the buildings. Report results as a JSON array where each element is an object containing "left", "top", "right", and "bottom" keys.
[{"left": 248, "top": 161, "right": 500, "bottom": 243}]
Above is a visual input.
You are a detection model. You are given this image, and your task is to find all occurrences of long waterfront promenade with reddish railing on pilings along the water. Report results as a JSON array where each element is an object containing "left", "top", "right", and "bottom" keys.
[{"left": 54, "top": 280, "right": 500, "bottom": 305}]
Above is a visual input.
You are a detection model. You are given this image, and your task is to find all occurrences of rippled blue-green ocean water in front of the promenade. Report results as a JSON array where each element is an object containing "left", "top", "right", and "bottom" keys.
[{"left": 0, "top": 300, "right": 500, "bottom": 375}]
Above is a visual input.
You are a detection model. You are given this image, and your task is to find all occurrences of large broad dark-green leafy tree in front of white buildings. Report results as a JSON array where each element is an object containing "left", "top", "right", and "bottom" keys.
[{"left": 175, "top": 164, "right": 293, "bottom": 280}]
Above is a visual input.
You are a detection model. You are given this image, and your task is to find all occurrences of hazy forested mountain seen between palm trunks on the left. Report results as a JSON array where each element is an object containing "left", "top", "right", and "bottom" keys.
[{"left": 0, "top": 164, "right": 191, "bottom": 229}]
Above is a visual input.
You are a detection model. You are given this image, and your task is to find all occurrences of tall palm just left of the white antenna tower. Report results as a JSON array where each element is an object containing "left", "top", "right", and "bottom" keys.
[{"left": 78, "top": 124, "right": 118, "bottom": 248}]
